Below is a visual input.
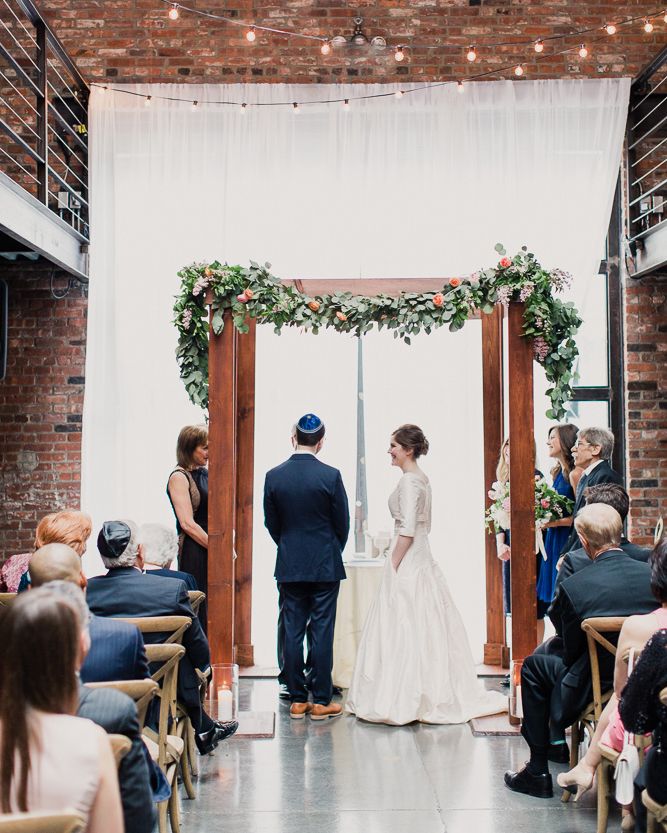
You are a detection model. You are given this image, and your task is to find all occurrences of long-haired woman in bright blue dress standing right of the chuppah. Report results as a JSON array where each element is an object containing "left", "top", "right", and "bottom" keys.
[{"left": 537, "top": 424, "right": 583, "bottom": 605}]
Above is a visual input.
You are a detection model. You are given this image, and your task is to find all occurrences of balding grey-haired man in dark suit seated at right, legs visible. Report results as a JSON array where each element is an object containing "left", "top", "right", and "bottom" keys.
[{"left": 505, "top": 503, "right": 655, "bottom": 798}]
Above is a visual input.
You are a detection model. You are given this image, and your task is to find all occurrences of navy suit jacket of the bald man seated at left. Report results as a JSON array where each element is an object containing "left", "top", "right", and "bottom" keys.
[{"left": 80, "top": 615, "right": 150, "bottom": 683}]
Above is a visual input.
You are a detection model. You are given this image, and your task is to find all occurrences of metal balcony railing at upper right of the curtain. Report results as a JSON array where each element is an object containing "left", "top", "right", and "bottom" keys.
[{"left": 627, "top": 48, "right": 667, "bottom": 250}]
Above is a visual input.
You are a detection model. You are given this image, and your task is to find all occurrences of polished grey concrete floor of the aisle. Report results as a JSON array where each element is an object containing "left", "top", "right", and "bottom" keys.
[{"left": 181, "top": 680, "right": 604, "bottom": 833}]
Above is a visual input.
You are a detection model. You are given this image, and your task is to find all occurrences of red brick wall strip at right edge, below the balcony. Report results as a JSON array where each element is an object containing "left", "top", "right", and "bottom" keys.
[{"left": 625, "top": 278, "right": 667, "bottom": 544}]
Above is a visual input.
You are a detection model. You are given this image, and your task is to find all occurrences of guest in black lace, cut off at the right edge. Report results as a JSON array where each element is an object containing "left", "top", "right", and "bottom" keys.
[{"left": 619, "top": 629, "right": 667, "bottom": 831}]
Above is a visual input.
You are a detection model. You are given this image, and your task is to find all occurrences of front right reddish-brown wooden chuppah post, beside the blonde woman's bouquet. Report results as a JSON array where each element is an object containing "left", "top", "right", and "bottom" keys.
[{"left": 507, "top": 302, "right": 537, "bottom": 661}]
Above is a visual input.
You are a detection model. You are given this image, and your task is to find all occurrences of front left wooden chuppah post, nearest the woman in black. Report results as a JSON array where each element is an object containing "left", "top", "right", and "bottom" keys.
[{"left": 208, "top": 310, "right": 238, "bottom": 663}]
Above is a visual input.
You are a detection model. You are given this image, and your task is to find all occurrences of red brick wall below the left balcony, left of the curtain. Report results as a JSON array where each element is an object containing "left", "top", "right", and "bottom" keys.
[{"left": 0, "top": 260, "right": 87, "bottom": 560}]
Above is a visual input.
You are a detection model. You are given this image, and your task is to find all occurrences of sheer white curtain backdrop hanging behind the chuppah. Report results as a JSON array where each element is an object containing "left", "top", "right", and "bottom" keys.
[{"left": 82, "top": 79, "right": 629, "bottom": 663}]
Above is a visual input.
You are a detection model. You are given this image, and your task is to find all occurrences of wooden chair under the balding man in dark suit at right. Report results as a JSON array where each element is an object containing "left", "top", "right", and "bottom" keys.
[{"left": 561, "top": 616, "right": 626, "bottom": 804}]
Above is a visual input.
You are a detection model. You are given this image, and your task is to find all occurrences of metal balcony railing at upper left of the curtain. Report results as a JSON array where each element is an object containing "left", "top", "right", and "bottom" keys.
[{"left": 0, "top": 0, "right": 89, "bottom": 239}]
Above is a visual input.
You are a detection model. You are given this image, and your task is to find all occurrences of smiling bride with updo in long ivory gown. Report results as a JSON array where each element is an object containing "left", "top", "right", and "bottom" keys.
[{"left": 345, "top": 425, "right": 507, "bottom": 726}]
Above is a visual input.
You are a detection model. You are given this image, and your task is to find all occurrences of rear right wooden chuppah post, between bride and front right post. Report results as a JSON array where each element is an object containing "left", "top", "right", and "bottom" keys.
[{"left": 482, "top": 304, "right": 509, "bottom": 668}]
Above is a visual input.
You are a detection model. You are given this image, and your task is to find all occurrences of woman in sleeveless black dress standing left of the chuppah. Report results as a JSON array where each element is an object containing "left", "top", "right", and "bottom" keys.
[{"left": 167, "top": 425, "right": 208, "bottom": 630}]
